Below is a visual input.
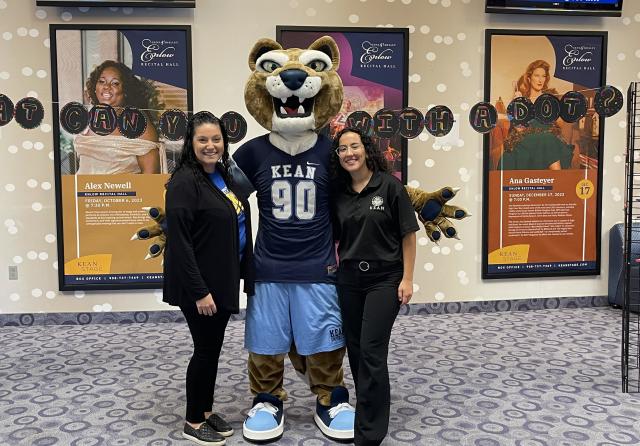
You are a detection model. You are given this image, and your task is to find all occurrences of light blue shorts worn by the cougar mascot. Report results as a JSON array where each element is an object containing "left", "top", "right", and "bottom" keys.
[{"left": 244, "top": 282, "right": 344, "bottom": 356}]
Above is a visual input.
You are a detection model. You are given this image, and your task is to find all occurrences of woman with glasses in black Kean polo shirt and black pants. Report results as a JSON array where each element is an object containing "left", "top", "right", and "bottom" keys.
[{"left": 331, "top": 128, "right": 419, "bottom": 445}]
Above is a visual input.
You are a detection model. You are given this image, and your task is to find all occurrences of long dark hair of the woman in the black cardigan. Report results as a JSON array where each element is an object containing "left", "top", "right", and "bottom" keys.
[{"left": 169, "top": 111, "right": 233, "bottom": 187}]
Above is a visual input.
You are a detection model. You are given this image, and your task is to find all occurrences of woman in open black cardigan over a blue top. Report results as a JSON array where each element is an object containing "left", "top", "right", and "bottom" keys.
[{"left": 164, "top": 112, "right": 253, "bottom": 445}]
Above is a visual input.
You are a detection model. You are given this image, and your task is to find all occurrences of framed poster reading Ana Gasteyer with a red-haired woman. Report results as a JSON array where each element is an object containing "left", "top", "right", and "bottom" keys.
[{"left": 482, "top": 29, "right": 607, "bottom": 279}]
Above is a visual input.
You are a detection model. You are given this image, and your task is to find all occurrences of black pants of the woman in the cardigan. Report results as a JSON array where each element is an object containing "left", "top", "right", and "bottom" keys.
[{"left": 180, "top": 303, "right": 231, "bottom": 423}]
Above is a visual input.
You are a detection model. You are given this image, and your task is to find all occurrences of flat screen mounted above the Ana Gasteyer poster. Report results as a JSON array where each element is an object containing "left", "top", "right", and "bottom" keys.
[{"left": 485, "top": 0, "right": 622, "bottom": 17}]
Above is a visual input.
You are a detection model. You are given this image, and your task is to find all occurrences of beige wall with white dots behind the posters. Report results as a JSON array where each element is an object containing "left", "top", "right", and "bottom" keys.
[{"left": 0, "top": 0, "right": 640, "bottom": 313}]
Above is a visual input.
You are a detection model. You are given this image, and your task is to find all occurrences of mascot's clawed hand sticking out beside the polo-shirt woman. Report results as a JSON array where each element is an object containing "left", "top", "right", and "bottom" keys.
[{"left": 406, "top": 186, "right": 471, "bottom": 243}]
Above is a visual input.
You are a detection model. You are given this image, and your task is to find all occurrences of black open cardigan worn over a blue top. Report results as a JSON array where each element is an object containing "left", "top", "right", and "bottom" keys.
[{"left": 163, "top": 166, "right": 254, "bottom": 313}]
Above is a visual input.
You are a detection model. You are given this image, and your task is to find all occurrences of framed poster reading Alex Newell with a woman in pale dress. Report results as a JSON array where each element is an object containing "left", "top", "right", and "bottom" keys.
[{"left": 50, "top": 25, "right": 193, "bottom": 291}]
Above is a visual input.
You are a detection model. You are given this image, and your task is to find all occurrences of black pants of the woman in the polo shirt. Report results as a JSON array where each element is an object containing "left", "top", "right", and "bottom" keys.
[{"left": 338, "top": 262, "right": 402, "bottom": 445}]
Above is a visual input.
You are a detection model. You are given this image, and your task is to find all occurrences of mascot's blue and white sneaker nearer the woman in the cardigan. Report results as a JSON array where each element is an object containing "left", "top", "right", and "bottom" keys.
[{"left": 242, "top": 393, "right": 284, "bottom": 443}]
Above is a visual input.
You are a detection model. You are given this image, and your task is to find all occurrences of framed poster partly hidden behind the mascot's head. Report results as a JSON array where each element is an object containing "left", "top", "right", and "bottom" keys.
[{"left": 276, "top": 26, "right": 409, "bottom": 183}]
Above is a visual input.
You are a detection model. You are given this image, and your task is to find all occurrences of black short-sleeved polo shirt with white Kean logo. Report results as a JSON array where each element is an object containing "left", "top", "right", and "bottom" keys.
[{"left": 333, "top": 172, "right": 420, "bottom": 263}]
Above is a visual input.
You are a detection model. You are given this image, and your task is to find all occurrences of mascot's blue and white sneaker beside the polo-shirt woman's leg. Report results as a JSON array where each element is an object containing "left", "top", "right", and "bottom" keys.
[{"left": 313, "top": 386, "right": 356, "bottom": 440}]
